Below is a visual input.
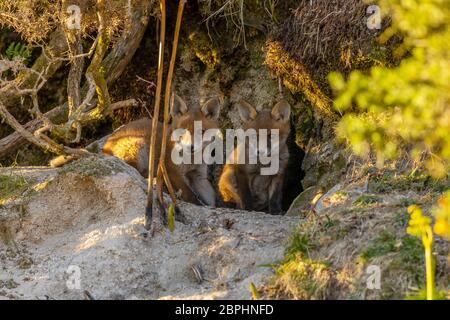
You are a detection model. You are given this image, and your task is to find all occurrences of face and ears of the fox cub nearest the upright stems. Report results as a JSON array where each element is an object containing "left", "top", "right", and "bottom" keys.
[{"left": 170, "top": 94, "right": 220, "bottom": 154}]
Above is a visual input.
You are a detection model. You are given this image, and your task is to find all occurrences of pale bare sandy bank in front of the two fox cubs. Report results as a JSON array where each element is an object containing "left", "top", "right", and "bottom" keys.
[{"left": 0, "top": 156, "right": 298, "bottom": 299}]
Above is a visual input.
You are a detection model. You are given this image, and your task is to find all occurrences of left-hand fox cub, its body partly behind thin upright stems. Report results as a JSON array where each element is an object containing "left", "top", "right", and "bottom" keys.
[{"left": 103, "top": 95, "right": 220, "bottom": 206}]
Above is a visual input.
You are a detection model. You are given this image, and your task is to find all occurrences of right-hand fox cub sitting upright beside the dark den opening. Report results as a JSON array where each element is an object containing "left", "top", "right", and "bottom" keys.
[{"left": 219, "top": 101, "right": 291, "bottom": 214}]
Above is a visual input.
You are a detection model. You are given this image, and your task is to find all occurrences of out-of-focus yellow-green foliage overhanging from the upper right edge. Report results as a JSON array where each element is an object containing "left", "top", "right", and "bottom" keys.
[{"left": 329, "top": 0, "right": 450, "bottom": 178}]
